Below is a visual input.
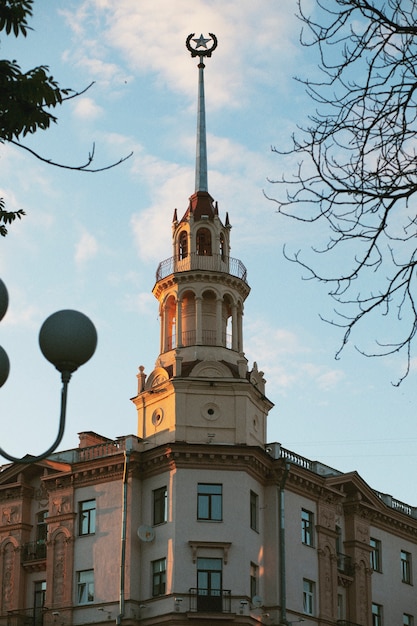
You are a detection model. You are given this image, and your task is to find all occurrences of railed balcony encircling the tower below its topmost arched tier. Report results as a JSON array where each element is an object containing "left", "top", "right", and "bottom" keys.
[{"left": 156, "top": 252, "right": 247, "bottom": 284}]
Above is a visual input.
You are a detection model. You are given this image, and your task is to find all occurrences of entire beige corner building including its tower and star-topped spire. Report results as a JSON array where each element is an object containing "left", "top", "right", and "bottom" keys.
[{"left": 0, "top": 35, "right": 417, "bottom": 626}]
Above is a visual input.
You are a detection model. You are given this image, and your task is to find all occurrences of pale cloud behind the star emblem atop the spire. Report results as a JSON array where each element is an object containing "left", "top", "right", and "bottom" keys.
[{"left": 62, "top": 0, "right": 300, "bottom": 107}]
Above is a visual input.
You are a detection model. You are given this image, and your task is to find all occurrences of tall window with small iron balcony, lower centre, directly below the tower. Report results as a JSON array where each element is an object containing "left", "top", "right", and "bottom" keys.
[{"left": 197, "top": 557, "right": 223, "bottom": 612}]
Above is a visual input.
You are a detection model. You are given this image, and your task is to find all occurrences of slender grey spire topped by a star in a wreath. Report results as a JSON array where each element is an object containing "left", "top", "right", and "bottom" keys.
[{"left": 186, "top": 33, "right": 217, "bottom": 192}]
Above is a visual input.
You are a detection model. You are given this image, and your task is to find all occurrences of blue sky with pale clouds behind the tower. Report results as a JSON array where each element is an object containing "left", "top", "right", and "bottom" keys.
[{"left": 0, "top": 0, "right": 417, "bottom": 506}]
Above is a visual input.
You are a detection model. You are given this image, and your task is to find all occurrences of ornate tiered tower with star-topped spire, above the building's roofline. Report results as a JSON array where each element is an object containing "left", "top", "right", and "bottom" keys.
[{"left": 133, "top": 33, "right": 272, "bottom": 446}]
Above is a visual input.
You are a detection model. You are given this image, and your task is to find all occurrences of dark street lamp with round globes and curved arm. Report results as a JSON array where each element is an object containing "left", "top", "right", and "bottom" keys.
[{"left": 0, "top": 279, "right": 97, "bottom": 463}]
